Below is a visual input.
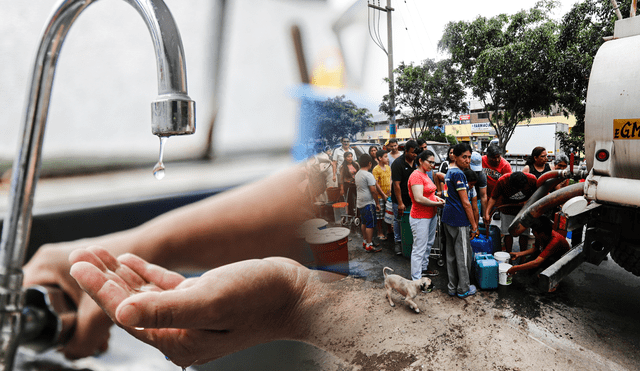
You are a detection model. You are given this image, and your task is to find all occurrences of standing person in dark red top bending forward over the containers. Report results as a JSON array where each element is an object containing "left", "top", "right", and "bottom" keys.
[{"left": 484, "top": 171, "right": 537, "bottom": 252}]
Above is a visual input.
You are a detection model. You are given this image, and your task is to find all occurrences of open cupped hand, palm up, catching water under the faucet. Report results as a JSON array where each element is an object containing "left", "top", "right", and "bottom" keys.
[{"left": 71, "top": 248, "right": 310, "bottom": 367}]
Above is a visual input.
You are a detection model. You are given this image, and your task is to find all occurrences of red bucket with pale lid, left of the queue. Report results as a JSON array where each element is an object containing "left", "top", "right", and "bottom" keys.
[{"left": 305, "top": 227, "right": 350, "bottom": 275}]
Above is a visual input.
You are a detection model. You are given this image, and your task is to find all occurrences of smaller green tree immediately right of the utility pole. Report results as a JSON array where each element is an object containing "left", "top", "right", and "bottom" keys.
[{"left": 380, "top": 59, "right": 467, "bottom": 138}]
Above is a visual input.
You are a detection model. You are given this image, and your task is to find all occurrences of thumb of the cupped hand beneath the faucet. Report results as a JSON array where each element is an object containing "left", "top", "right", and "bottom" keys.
[{"left": 116, "top": 289, "right": 212, "bottom": 328}]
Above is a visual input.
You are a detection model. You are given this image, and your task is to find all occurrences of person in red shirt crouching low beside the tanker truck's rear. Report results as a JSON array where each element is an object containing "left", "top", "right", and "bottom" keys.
[{"left": 507, "top": 217, "right": 570, "bottom": 280}]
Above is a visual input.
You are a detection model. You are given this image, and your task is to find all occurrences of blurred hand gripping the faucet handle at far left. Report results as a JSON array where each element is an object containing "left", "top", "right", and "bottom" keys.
[{"left": 23, "top": 244, "right": 113, "bottom": 359}]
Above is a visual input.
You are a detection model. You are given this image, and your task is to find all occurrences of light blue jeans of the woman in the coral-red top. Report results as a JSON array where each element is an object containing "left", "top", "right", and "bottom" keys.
[{"left": 409, "top": 216, "right": 438, "bottom": 280}]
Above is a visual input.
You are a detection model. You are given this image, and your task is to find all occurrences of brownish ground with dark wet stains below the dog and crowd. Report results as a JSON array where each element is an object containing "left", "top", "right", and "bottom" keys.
[{"left": 296, "top": 232, "right": 638, "bottom": 371}]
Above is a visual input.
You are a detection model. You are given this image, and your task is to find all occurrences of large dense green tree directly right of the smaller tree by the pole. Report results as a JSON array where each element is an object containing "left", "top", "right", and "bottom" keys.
[{"left": 438, "top": 0, "right": 558, "bottom": 151}]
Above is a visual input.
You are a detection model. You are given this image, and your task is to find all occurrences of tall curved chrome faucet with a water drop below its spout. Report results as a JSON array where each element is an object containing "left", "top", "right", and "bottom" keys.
[{"left": 0, "top": 0, "right": 195, "bottom": 371}]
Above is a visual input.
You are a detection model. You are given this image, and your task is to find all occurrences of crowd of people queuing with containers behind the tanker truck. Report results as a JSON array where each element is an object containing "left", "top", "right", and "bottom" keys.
[{"left": 324, "top": 138, "right": 569, "bottom": 298}]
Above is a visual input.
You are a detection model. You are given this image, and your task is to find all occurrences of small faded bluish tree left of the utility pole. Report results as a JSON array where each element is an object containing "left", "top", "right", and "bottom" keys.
[{"left": 312, "top": 95, "right": 373, "bottom": 145}]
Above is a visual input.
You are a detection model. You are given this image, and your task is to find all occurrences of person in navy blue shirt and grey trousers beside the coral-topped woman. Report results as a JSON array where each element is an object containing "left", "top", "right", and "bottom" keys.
[{"left": 442, "top": 143, "right": 478, "bottom": 298}]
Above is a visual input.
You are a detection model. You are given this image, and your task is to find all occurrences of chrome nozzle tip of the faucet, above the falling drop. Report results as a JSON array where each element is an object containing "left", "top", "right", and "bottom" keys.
[{"left": 151, "top": 95, "right": 196, "bottom": 137}]
